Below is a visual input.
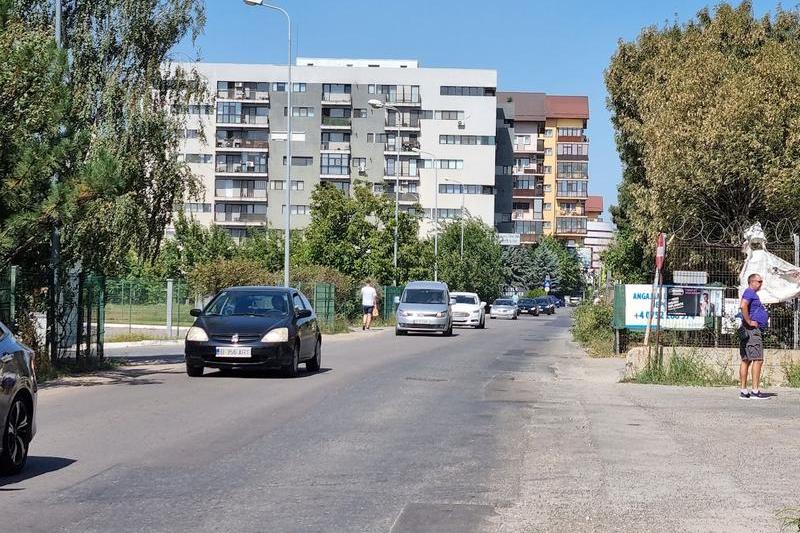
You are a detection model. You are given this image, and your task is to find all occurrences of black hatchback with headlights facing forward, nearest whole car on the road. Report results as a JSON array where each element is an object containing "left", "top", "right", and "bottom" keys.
[{"left": 185, "top": 287, "right": 322, "bottom": 377}]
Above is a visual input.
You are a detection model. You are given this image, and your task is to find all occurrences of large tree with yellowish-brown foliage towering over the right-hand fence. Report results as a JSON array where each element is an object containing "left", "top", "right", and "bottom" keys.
[{"left": 605, "top": 1, "right": 800, "bottom": 278}]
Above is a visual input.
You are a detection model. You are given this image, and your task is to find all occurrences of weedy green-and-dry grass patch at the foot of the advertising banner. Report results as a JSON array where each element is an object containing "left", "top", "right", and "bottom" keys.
[{"left": 623, "top": 352, "right": 736, "bottom": 387}]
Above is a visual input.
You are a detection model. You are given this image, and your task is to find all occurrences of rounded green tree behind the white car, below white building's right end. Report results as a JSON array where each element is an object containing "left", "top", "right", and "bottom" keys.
[{"left": 439, "top": 217, "right": 505, "bottom": 301}]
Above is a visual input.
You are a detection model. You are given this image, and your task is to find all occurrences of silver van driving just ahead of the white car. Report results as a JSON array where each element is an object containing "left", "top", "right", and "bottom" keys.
[{"left": 394, "top": 281, "right": 455, "bottom": 337}]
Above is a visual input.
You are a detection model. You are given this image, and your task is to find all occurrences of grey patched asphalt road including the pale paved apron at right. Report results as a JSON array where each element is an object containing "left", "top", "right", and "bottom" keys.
[{"left": 0, "top": 311, "right": 800, "bottom": 533}]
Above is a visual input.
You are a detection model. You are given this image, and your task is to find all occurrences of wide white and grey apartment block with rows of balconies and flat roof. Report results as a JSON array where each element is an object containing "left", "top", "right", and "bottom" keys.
[{"left": 177, "top": 58, "right": 496, "bottom": 240}]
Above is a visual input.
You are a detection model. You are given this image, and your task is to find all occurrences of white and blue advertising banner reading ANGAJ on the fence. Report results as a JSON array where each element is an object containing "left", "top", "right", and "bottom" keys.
[{"left": 625, "top": 285, "right": 723, "bottom": 330}]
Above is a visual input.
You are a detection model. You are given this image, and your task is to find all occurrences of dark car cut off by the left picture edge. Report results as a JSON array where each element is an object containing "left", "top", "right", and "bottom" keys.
[{"left": 0, "top": 322, "right": 37, "bottom": 475}]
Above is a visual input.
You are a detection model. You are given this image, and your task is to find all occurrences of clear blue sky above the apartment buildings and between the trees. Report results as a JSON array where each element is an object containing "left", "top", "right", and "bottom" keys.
[{"left": 174, "top": 0, "right": 789, "bottom": 218}]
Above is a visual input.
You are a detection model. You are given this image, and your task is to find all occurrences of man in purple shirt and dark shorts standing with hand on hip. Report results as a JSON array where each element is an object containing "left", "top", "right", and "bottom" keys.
[{"left": 739, "top": 274, "right": 769, "bottom": 400}]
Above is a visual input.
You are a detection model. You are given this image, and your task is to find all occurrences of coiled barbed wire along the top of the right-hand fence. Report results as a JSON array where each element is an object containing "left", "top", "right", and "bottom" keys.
[{"left": 665, "top": 216, "right": 800, "bottom": 246}]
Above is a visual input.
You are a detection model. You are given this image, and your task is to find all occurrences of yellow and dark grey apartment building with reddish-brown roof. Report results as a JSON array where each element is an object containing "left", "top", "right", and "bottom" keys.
[{"left": 495, "top": 92, "right": 588, "bottom": 247}]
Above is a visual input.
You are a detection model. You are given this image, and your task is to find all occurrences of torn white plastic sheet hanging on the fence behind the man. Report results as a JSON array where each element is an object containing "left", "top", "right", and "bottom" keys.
[{"left": 739, "top": 223, "right": 800, "bottom": 304}]
